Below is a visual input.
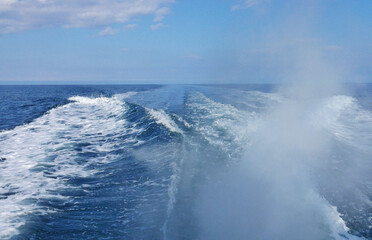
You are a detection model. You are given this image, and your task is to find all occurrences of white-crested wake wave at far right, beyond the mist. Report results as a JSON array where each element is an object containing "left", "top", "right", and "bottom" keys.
[{"left": 313, "top": 95, "right": 372, "bottom": 237}]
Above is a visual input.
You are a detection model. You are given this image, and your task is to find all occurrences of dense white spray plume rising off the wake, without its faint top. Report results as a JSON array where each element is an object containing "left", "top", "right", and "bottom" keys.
[{"left": 198, "top": 42, "right": 364, "bottom": 239}]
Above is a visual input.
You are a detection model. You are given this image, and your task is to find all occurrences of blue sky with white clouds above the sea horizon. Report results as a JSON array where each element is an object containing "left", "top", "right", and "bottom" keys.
[{"left": 0, "top": 0, "right": 372, "bottom": 84}]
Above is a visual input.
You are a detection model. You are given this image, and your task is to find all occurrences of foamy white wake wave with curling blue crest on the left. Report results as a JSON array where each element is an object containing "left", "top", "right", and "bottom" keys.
[{"left": 0, "top": 93, "right": 186, "bottom": 239}]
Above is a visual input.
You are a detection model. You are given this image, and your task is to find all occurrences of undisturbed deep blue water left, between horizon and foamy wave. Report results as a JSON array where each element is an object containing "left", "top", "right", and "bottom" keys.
[{"left": 0, "top": 85, "right": 157, "bottom": 129}]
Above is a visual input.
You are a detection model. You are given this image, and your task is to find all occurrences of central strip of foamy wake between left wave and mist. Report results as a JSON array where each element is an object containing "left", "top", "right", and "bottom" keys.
[{"left": 163, "top": 90, "right": 268, "bottom": 239}]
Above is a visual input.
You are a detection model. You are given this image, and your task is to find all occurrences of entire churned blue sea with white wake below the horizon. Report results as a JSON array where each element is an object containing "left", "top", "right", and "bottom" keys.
[{"left": 0, "top": 85, "right": 372, "bottom": 240}]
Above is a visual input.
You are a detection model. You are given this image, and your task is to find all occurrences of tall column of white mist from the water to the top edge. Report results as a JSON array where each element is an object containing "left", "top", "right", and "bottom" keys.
[{"left": 196, "top": 1, "right": 366, "bottom": 240}]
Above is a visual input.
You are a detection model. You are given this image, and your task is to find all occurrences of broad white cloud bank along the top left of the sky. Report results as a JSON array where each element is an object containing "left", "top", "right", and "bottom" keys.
[{"left": 0, "top": 0, "right": 174, "bottom": 33}]
